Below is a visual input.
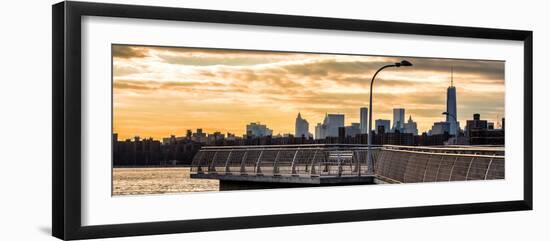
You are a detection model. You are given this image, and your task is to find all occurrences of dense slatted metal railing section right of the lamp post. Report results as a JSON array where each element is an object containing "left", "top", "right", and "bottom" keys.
[{"left": 375, "top": 146, "right": 504, "bottom": 183}]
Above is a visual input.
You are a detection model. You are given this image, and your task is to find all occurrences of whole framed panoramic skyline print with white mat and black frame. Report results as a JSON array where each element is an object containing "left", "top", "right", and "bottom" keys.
[{"left": 52, "top": 1, "right": 533, "bottom": 239}]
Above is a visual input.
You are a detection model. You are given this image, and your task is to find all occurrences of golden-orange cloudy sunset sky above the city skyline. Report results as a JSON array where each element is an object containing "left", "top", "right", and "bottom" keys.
[{"left": 112, "top": 45, "right": 505, "bottom": 139}]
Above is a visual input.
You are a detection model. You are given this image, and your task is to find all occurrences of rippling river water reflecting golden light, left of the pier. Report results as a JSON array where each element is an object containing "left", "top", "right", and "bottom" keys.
[{"left": 113, "top": 167, "right": 219, "bottom": 196}]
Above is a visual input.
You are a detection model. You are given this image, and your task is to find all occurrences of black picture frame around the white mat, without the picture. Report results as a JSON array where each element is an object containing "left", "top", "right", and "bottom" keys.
[{"left": 52, "top": 2, "right": 533, "bottom": 240}]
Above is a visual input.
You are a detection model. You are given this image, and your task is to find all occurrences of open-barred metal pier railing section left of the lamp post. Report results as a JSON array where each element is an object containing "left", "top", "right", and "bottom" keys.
[{"left": 191, "top": 145, "right": 380, "bottom": 177}]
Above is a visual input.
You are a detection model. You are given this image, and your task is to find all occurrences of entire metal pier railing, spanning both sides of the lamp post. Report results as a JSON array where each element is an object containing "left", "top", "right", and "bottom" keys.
[{"left": 191, "top": 144, "right": 504, "bottom": 183}]
